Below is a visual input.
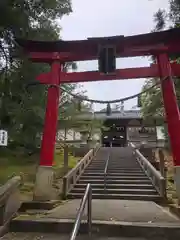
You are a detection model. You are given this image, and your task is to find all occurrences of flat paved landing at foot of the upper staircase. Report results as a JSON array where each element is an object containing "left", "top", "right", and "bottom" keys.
[{"left": 45, "top": 199, "right": 180, "bottom": 223}]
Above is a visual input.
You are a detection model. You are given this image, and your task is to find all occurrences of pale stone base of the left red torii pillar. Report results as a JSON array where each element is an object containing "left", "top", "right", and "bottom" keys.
[{"left": 33, "top": 166, "right": 55, "bottom": 201}]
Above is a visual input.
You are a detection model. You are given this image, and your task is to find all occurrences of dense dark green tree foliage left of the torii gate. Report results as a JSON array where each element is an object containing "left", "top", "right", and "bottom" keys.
[{"left": 0, "top": 0, "right": 75, "bottom": 154}]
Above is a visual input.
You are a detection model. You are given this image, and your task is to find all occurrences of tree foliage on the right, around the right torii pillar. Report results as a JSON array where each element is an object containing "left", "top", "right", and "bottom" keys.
[{"left": 141, "top": 0, "right": 180, "bottom": 141}]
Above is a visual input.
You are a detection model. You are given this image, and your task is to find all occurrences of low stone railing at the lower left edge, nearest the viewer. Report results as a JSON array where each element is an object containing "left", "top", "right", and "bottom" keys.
[{"left": 0, "top": 176, "right": 21, "bottom": 231}]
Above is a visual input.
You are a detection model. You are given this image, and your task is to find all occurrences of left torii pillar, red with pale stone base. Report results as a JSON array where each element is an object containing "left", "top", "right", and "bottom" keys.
[{"left": 34, "top": 62, "right": 61, "bottom": 201}]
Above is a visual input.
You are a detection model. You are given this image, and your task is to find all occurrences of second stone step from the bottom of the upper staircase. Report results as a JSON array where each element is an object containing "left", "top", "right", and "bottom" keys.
[{"left": 71, "top": 188, "right": 157, "bottom": 195}]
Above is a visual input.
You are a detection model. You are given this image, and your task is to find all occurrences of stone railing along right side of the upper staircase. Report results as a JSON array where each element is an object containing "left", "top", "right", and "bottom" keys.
[{"left": 129, "top": 143, "right": 166, "bottom": 198}]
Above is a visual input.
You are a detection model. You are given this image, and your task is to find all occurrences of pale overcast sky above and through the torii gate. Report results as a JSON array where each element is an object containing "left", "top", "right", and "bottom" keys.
[{"left": 60, "top": 0, "right": 169, "bottom": 110}]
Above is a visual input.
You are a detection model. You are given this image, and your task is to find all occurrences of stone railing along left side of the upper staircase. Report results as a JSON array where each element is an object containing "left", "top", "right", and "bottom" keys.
[{"left": 62, "top": 144, "right": 100, "bottom": 199}]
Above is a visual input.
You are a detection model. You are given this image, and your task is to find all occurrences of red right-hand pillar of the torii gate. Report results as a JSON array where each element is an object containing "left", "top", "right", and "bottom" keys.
[{"left": 157, "top": 53, "right": 180, "bottom": 203}]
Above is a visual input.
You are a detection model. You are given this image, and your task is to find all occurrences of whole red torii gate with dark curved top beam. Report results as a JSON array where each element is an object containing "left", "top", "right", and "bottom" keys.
[{"left": 17, "top": 28, "right": 180, "bottom": 199}]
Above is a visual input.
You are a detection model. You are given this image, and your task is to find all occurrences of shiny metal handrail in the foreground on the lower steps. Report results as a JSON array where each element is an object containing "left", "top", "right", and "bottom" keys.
[{"left": 70, "top": 183, "right": 92, "bottom": 240}]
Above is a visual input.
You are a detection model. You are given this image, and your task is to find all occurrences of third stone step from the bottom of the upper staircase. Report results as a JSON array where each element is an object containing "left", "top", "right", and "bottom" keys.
[{"left": 74, "top": 183, "right": 154, "bottom": 189}]
